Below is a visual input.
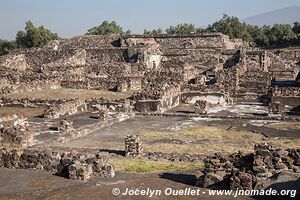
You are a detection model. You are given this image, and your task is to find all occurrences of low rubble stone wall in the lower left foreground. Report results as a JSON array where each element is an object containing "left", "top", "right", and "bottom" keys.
[{"left": 0, "top": 149, "right": 115, "bottom": 181}]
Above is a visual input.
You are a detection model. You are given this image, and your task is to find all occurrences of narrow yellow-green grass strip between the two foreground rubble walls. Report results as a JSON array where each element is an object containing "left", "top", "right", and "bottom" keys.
[{"left": 112, "top": 159, "right": 204, "bottom": 173}]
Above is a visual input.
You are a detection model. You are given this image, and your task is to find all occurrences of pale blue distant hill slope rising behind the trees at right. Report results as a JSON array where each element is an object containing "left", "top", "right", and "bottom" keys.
[{"left": 241, "top": 6, "right": 300, "bottom": 26}]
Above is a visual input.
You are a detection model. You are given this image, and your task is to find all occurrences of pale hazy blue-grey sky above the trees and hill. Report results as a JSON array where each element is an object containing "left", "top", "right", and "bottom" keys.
[{"left": 0, "top": 0, "right": 300, "bottom": 39}]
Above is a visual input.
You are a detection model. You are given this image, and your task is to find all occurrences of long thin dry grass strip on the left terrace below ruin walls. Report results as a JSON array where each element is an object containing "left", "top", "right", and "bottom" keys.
[{"left": 7, "top": 88, "right": 133, "bottom": 100}]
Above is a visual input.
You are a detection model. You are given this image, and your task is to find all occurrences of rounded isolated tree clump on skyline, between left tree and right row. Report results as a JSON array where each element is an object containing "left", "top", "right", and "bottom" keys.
[{"left": 86, "top": 20, "right": 124, "bottom": 35}]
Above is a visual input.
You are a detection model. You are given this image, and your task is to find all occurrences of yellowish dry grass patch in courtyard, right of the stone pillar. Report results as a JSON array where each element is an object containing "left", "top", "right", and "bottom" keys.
[{"left": 127, "top": 126, "right": 300, "bottom": 155}]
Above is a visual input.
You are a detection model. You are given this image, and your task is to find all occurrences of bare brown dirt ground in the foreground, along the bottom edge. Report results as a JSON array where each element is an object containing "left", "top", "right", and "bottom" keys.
[{"left": 0, "top": 169, "right": 251, "bottom": 200}]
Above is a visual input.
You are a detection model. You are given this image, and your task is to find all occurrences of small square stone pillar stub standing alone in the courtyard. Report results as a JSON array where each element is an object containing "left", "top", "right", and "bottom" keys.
[{"left": 125, "top": 135, "right": 143, "bottom": 156}]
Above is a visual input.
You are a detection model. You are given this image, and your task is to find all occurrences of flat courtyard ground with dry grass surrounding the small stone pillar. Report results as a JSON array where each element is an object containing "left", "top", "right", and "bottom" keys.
[{"left": 54, "top": 116, "right": 300, "bottom": 155}]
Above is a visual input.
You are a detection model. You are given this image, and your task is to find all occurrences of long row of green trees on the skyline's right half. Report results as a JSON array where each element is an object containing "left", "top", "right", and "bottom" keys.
[{"left": 144, "top": 14, "right": 300, "bottom": 48}]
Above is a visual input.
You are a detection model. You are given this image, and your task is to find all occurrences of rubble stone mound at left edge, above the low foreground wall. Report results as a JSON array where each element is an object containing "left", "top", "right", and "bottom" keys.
[{"left": 0, "top": 115, "right": 33, "bottom": 147}]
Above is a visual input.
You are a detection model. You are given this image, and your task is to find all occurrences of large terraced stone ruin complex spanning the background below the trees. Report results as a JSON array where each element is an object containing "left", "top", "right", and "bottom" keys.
[{"left": 0, "top": 33, "right": 300, "bottom": 114}]
